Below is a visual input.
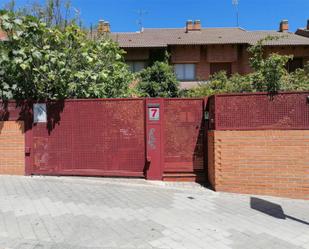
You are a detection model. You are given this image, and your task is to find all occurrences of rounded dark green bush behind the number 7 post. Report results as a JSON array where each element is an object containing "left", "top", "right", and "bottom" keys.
[{"left": 136, "top": 61, "right": 179, "bottom": 97}]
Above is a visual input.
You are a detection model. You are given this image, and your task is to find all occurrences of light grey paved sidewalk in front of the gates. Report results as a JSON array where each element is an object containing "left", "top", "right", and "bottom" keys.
[{"left": 0, "top": 176, "right": 309, "bottom": 249}]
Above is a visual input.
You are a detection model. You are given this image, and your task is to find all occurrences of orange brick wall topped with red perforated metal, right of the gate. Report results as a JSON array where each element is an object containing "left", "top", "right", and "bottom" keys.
[{"left": 208, "top": 93, "right": 309, "bottom": 199}]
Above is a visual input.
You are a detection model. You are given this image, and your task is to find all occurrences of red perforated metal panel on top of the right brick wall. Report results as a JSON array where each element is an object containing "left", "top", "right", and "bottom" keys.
[{"left": 210, "top": 93, "right": 309, "bottom": 130}]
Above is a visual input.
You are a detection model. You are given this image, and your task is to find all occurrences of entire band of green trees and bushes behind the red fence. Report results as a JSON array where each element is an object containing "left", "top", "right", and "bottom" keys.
[{"left": 0, "top": 10, "right": 309, "bottom": 100}]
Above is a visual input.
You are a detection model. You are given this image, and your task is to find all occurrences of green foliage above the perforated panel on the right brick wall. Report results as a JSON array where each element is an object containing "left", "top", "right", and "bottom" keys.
[{"left": 185, "top": 37, "right": 309, "bottom": 97}]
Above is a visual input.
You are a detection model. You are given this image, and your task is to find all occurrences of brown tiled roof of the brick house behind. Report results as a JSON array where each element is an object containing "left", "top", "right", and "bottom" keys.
[{"left": 110, "top": 28, "right": 309, "bottom": 48}]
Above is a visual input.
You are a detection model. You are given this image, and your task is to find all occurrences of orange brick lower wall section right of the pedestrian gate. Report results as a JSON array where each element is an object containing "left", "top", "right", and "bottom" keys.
[{"left": 208, "top": 130, "right": 309, "bottom": 199}]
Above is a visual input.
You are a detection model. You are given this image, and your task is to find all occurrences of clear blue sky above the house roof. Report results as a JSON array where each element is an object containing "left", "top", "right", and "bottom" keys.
[{"left": 0, "top": 0, "right": 309, "bottom": 32}]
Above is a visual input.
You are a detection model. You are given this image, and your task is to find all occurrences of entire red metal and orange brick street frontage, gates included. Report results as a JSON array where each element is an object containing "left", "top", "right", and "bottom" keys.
[{"left": 0, "top": 92, "right": 309, "bottom": 199}]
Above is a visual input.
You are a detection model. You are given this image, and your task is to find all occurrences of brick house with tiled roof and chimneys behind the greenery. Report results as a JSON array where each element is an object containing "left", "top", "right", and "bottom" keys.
[{"left": 98, "top": 20, "right": 309, "bottom": 88}]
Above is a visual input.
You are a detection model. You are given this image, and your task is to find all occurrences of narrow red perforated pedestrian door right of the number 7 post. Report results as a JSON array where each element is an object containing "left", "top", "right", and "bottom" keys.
[{"left": 164, "top": 99, "right": 204, "bottom": 172}]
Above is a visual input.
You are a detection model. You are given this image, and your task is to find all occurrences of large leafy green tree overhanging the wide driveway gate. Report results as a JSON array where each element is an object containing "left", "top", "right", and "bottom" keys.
[{"left": 0, "top": 12, "right": 132, "bottom": 100}]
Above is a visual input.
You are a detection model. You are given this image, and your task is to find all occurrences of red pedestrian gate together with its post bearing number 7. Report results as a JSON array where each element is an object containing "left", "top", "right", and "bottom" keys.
[{"left": 147, "top": 98, "right": 207, "bottom": 181}]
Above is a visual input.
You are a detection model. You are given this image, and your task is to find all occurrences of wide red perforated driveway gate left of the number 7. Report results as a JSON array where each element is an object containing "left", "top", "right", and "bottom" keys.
[{"left": 32, "top": 99, "right": 145, "bottom": 176}]
